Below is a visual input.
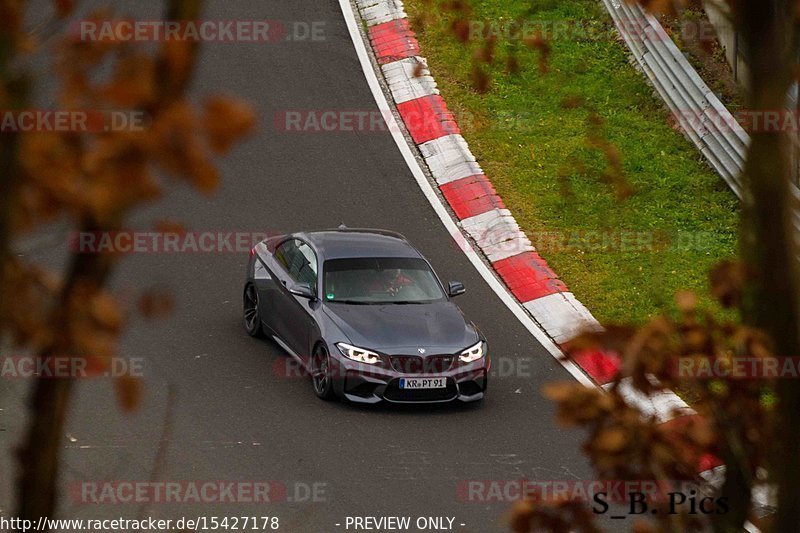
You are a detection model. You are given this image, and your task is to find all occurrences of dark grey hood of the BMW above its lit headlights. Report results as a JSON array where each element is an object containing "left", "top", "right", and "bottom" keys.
[{"left": 324, "top": 301, "right": 479, "bottom": 355}]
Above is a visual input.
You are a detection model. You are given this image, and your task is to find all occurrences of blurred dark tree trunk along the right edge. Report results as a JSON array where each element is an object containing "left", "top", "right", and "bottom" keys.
[{"left": 726, "top": 0, "right": 800, "bottom": 531}]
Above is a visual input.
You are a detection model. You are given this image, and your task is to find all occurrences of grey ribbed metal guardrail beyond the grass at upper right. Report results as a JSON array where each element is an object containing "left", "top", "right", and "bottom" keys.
[{"left": 602, "top": 0, "right": 750, "bottom": 198}]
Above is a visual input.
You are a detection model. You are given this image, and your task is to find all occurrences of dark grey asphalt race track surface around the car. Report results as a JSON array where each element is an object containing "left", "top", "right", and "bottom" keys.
[{"left": 0, "top": 0, "right": 620, "bottom": 532}]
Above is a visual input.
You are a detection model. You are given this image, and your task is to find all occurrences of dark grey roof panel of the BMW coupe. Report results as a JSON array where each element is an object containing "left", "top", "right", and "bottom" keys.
[{"left": 296, "top": 228, "right": 422, "bottom": 261}]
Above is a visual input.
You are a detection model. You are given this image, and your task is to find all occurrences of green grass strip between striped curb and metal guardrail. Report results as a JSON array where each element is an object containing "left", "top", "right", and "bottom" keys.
[{"left": 406, "top": 0, "right": 739, "bottom": 324}]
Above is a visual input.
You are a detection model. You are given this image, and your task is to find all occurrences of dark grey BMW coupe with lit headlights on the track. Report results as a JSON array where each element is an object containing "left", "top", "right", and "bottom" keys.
[{"left": 244, "top": 227, "right": 491, "bottom": 403}]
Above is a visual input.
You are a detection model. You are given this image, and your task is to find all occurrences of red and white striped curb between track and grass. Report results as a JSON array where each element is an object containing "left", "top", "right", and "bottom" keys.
[{"left": 340, "top": 0, "right": 719, "bottom": 473}]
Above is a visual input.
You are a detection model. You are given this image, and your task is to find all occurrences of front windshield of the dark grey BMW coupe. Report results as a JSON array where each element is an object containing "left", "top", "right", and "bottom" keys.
[{"left": 324, "top": 257, "right": 445, "bottom": 304}]
